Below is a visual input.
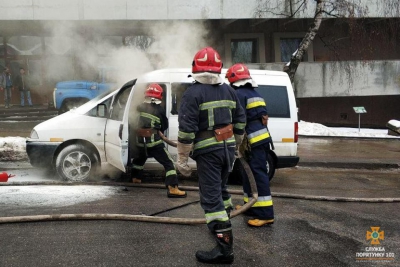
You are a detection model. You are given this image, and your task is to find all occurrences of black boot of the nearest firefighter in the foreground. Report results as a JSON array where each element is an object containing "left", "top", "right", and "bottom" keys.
[{"left": 196, "top": 224, "right": 234, "bottom": 264}]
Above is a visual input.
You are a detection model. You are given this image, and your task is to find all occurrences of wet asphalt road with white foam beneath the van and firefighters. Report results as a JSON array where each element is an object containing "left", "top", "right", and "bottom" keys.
[{"left": 0, "top": 167, "right": 400, "bottom": 266}]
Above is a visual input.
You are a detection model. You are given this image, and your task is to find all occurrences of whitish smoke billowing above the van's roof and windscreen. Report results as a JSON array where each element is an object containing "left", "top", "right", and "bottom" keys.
[{"left": 44, "top": 21, "right": 209, "bottom": 86}]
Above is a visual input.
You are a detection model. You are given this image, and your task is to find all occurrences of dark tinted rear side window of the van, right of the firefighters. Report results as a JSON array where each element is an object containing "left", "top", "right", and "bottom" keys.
[{"left": 256, "top": 85, "right": 290, "bottom": 118}]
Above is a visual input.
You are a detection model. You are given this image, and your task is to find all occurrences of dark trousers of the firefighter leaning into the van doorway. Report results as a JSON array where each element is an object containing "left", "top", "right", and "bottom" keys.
[{"left": 132, "top": 144, "right": 179, "bottom": 186}]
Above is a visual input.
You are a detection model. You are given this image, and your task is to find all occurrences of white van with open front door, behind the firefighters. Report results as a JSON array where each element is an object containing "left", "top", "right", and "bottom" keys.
[{"left": 27, "top": 69, "right": 299, "bottom": 180}]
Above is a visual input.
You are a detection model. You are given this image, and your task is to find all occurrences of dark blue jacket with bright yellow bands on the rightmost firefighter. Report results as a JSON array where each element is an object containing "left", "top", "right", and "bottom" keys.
[{"left": 234, "top": 83, "right": 271, "bottom": 147}]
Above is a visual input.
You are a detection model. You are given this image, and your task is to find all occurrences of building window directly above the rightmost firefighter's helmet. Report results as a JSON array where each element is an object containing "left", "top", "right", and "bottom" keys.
[{"left": 221, "top": 33, "right": 265, "bottom": 66}]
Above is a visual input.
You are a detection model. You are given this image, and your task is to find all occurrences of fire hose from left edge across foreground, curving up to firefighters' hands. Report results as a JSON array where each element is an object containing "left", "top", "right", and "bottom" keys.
[{"left": 0, "top": 132, "right": 258, "bottom": 224}]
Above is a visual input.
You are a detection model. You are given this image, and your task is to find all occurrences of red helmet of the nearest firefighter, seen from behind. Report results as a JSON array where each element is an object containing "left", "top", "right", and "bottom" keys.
[{"left": 192, "top": 47, "right": 222, "bottom": 73}]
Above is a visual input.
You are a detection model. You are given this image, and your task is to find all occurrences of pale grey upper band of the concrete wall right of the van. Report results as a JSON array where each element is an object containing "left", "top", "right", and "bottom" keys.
[{"left": 249, "top": 61, "right": 400, "bottom": 98}]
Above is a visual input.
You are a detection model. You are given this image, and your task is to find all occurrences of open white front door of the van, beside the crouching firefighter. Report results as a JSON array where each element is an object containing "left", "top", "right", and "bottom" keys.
[{"left": 105, "top": 82, "right": 134, "bottom": 172}]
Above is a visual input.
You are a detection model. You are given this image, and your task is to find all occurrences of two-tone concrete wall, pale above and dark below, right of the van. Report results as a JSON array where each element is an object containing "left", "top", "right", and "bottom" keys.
[{"left": 249, "top": 61, "right": 400, "bottom": 129}]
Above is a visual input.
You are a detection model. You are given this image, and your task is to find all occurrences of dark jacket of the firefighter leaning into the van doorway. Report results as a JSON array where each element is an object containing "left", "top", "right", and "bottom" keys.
[{"left": 137, "top": 103, "right": 168, "bottom": 148}]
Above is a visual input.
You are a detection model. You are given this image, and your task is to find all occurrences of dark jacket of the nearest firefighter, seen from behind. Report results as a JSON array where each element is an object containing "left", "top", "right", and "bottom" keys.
[{"left": 178, "top": 82, "right": 246, "bottom": 158}]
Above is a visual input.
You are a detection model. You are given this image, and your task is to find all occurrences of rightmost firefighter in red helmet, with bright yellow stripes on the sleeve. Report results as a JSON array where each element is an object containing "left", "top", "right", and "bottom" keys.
[{"left": 226, "top": 63, "right": 274, "bottom": 227}]
